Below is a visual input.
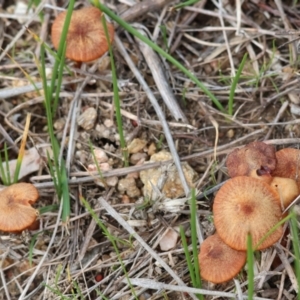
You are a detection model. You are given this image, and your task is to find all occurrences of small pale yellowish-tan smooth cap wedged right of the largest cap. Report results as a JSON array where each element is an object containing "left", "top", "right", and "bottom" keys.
[{"left": 270, "top": 177, "right": 299, "bottom": 210}]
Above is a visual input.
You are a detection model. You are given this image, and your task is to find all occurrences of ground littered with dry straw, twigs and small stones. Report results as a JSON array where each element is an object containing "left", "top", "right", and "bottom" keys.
[{"left": 0, "top": 0, "right": 300, "bottom": 300}]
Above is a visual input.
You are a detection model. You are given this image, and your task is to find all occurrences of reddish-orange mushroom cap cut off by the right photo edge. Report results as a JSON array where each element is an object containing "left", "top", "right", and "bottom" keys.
[{"left": 272, "top": 148, "right": 300, "bottom": 190}]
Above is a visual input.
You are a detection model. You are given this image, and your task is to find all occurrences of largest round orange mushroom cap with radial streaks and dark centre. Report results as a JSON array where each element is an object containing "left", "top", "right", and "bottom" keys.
[{"left": 213, "top": 176, "right": 282, "bottom": 250}]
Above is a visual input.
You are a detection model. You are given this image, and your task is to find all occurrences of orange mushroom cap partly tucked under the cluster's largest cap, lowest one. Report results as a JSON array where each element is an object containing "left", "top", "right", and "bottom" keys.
[{"left": 198, "top": 234, "right": 247, "bottom": 283}]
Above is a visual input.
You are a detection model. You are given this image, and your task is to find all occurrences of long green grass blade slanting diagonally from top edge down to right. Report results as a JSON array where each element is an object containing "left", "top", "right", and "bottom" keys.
[{"left": 90, "top": 0, "right": 225, "bottom": 112}]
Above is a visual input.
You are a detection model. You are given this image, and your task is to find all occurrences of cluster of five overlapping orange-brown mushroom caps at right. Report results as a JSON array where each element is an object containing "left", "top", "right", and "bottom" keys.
[{"left": 198, "top": 142, "right": 300, "bottom": 283}]
